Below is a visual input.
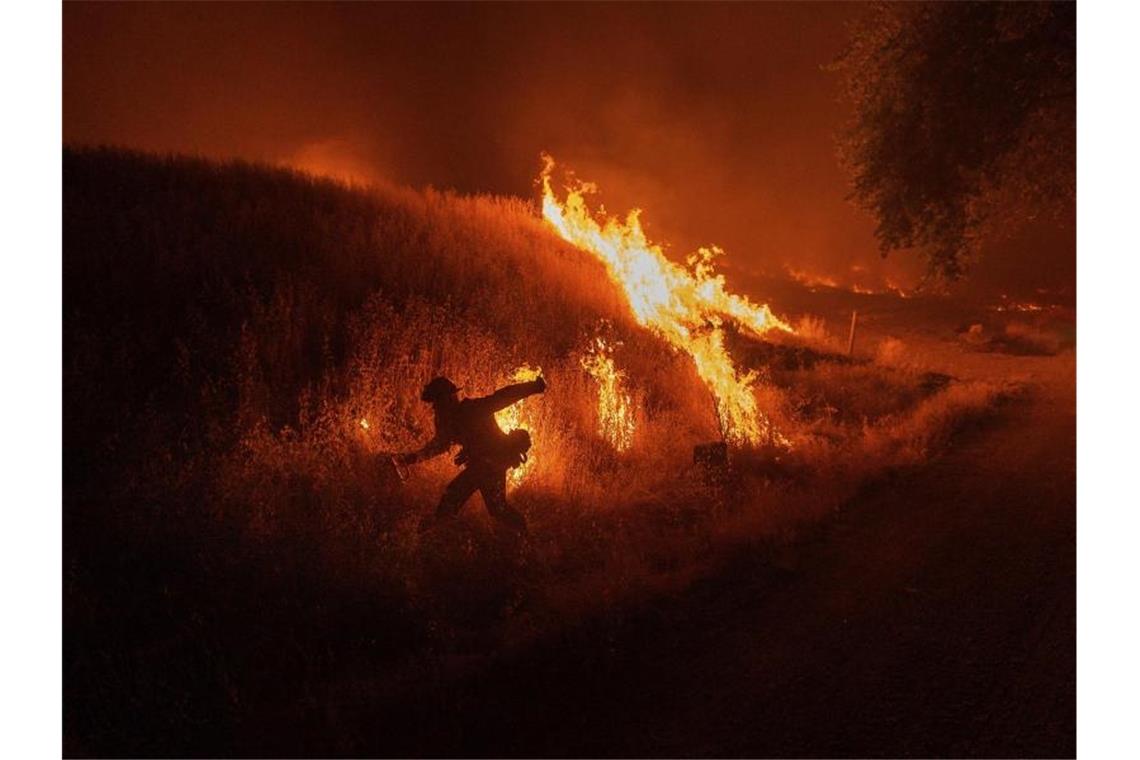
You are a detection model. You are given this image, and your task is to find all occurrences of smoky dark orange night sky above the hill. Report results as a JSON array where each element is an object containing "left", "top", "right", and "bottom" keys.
[{"left": 63, "top": 3, "right": 1075, "bottom": 300}]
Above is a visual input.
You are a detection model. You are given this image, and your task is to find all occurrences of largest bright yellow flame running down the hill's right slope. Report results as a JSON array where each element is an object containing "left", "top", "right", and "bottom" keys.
[{"left": 540, "top": 155, "right": 792, "bottom": 443}]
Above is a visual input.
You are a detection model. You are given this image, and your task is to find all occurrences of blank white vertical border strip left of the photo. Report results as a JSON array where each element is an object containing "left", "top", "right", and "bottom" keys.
[{"left": 0, "top": 2, "right": 63, "bottom": 758}]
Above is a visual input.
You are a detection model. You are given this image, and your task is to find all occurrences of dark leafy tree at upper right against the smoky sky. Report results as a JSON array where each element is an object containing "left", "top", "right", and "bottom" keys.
[{"left": 832, "top": 2, "right": 1076, "bottom": 280}]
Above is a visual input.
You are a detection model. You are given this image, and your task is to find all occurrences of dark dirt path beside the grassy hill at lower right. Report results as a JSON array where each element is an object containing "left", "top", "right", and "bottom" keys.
[{"left": 373, "top": 357, "right": 1076, "bottom": 757}]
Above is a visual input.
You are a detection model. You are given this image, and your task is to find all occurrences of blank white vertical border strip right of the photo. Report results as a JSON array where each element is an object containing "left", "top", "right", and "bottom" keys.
[{"left": 1077, "top": 1, "right": 1140, "bottom": 758}]
